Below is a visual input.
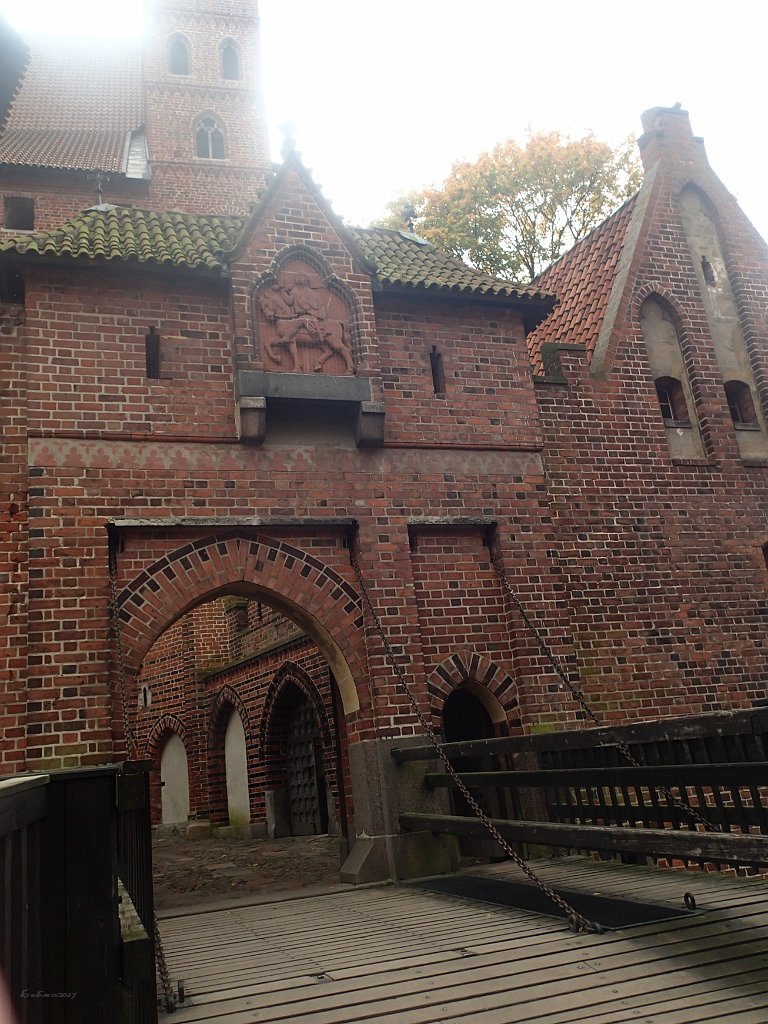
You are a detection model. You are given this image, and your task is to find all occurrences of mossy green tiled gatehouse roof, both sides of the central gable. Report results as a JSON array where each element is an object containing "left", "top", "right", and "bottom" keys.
[{"left": 0, "top": 204, "right": 553, "bottom": 306}]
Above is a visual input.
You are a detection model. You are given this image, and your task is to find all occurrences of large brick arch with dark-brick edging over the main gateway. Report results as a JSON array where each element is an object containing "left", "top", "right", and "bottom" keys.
[{"left": 113, "top": 530, "right": 370, "bottom": 717}]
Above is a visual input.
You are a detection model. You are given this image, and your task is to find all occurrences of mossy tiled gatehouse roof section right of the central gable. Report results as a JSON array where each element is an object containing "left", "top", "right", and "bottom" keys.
[{"left": 348, "top": 227, "right": 551, "bottom": 300}]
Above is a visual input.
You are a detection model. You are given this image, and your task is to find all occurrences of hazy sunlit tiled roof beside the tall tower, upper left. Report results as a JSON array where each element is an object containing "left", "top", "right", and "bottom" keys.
[{"left": 0, "top": 38, "right": 144, "bottom": 171}]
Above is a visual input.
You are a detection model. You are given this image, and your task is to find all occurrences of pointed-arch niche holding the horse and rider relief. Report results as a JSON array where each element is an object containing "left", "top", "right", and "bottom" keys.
[{"left": 252, "top": 247, "right": 354, "bottom": 377}]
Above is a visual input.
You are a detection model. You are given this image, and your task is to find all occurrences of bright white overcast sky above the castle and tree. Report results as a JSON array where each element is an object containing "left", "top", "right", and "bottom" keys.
[{"left": 0, "top": 0, "right": 768, "bottom": 238}]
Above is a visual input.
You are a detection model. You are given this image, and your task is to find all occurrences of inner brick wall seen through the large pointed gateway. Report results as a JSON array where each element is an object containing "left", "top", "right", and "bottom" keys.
[{"left": 131, "top": 598, "right": 349, "bottom": 824}]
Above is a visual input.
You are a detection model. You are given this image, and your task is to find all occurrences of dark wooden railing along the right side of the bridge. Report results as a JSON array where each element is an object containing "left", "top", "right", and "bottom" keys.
[{"left": 392, "top": 711, "right": 768, "bottom": 867}]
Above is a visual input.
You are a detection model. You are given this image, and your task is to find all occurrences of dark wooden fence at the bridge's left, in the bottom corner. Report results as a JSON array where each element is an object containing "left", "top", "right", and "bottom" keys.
[{"left": 0, "top": 763, "right": 157, "bottom": 1024}]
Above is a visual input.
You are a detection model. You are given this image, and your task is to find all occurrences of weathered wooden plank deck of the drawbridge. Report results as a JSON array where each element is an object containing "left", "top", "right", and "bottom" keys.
[{"left": 160, "top": 857, "right": 768, "bottom": 1024}]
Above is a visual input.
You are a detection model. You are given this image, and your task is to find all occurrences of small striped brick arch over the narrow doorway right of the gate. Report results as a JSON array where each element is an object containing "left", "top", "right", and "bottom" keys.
[{"left": 427, "top": 650, "right": 519, "bottom": 726}]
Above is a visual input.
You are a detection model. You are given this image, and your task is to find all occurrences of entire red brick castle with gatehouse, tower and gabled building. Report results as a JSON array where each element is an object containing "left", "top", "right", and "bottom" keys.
[{"left": 0, "top": 0, "right": 768, "bottom": 879}]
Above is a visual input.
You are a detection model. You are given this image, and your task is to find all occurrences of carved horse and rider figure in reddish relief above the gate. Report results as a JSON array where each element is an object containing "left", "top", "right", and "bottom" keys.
[{"left": 258, "top": 273, "right": 352, "bottom": 373}]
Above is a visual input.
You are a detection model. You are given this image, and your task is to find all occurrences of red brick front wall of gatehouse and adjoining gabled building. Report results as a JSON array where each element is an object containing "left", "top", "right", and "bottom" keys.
[{"left": 3, "top": 103, "right": 768, "bottom": 778}]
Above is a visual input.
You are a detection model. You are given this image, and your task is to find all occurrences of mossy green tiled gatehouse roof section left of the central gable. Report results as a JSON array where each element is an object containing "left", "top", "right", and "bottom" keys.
[{"left": 0, "top": 205, "right": 244, "bottom": 270}]
